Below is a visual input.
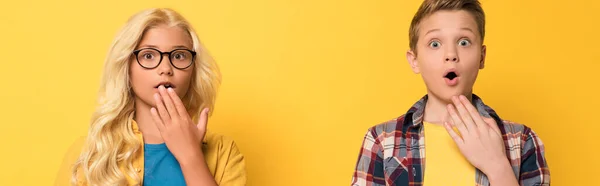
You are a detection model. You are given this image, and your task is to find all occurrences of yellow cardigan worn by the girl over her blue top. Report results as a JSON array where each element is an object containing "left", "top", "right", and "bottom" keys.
[{"left": 55, "top": 121, "right": 246, "bottom": 186}]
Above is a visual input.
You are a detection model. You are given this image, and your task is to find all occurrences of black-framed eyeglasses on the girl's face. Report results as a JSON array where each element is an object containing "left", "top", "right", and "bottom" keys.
[{"left": 133, "top": 48, "right": 196, "bottom": 70}]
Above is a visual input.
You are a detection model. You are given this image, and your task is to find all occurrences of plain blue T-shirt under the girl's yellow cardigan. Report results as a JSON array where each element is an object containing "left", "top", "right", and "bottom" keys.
[{"left": 143, "top": 143, "right": 185, "bottom": 186}]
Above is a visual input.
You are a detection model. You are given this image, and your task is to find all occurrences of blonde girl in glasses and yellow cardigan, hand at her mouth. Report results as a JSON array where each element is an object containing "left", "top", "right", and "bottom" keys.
[{"left": 56, "top": 9, "right": 246, "bottom": 186}]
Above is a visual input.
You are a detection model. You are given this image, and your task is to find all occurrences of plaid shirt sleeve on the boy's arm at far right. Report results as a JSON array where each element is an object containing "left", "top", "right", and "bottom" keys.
[{"left": 519, "top": 128, "right": 550, "bottom": 186}]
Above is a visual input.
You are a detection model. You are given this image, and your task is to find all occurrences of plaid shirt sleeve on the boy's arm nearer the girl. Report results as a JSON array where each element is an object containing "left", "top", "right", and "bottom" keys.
[{"left": 351, "top": 129, "right": 385, "bottom": 186}]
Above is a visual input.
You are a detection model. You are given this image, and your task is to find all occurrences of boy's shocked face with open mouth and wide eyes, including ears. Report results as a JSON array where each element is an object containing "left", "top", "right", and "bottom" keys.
[{"left": 406, "top": 10, "right": 486, "bottom": 101}]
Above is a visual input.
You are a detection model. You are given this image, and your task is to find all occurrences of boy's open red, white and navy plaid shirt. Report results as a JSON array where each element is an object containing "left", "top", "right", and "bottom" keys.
[{"left": 351, "top": 94, "right": 550, "bottom": 186}]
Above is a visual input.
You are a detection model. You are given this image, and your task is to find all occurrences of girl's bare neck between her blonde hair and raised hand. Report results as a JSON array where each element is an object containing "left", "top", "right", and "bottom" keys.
[{"left": 133, "top": 97, "right": 164, "bottom": 144}]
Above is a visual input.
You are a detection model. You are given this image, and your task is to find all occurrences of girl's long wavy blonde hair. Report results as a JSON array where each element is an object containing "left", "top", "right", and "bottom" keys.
[{"left": 71, "top": 9, "right": 221, "bottom": 186}]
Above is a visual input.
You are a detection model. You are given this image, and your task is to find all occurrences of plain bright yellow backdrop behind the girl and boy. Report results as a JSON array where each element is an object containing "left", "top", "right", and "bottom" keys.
[{"left": 0, "top": 0, "right": 600, "bottom": 186}]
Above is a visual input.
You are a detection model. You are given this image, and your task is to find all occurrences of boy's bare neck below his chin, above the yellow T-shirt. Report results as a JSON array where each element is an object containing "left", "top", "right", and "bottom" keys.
[{"left": 423, "top": 91, "right": 473, "bottom": 125}]
